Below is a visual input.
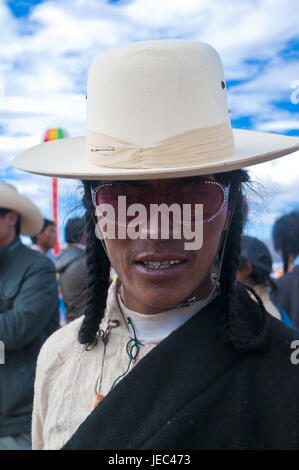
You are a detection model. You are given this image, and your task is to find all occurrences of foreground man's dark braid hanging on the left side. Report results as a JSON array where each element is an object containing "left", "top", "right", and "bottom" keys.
[{"left": 78, "top": 181, "right": 110, "bottom": 347}]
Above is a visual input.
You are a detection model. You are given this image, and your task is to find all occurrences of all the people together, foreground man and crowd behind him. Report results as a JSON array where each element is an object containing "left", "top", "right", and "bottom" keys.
[{"left": 0, "top": 40, "right": 299, "bottom": 450}]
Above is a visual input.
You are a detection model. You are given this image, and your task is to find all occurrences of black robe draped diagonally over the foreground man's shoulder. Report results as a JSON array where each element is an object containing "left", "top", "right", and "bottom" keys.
[{"left": 63, "top": 288, "right": 299, "bottom": 453}]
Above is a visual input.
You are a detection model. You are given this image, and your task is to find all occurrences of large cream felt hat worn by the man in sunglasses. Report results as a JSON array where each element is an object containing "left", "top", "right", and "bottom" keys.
[{"left": 13, "top": 40, "right": 299, "bottom": 180}]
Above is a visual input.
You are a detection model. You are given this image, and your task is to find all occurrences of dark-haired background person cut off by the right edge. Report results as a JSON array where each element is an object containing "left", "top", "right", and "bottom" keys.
[{"left": 271, "top": 212, "right": 299, "bottom": 329}]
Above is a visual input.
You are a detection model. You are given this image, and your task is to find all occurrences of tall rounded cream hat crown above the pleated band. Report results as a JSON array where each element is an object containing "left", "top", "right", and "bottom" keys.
[{"left": 87, "top": 40, "right": 229, "bottom": 146}]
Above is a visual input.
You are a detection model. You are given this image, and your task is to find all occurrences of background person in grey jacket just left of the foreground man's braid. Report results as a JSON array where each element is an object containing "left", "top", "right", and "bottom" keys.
[{"left": 55, "top": 218, "right": 88, "bottom": 322}]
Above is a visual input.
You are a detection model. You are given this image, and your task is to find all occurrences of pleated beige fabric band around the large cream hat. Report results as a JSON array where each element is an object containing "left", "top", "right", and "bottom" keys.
[{"left": 87, "top": 122, "right": 235, "bottom": 169}]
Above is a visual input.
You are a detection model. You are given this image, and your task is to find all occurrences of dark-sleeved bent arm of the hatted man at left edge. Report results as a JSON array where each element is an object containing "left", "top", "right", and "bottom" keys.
[{"left": 0, "top": 257, "right": 59, "bottom": 351}]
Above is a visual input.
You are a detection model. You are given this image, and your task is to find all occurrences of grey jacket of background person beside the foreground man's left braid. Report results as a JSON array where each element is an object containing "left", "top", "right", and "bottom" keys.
[{"left": 55, "top": 243, "right": 88, "bottom": 322}]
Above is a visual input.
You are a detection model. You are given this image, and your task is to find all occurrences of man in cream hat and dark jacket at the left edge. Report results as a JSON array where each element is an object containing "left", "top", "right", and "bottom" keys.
[{"left": 0, "top": 181, "right": 59, "bottom": 450}]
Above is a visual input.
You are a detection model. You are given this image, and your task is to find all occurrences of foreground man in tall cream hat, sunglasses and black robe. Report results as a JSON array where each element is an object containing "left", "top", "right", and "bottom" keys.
[{"left": 14, "top": 40, "right": 299, "bottom": 452}]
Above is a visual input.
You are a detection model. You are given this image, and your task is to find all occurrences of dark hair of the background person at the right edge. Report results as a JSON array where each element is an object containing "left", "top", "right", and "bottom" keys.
[{"left": 273, "top": 211, "right": 299, "bottom": 273}]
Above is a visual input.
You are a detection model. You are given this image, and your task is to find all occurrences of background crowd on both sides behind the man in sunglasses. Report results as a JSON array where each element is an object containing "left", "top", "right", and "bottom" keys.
[{"left": 0, "top": 181, "right": 299, "bottom": 449}]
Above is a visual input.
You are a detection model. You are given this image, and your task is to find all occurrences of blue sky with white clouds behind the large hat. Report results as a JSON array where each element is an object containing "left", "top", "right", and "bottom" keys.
[{"left": 0, "top": 0, "right": 299, "bottom": 250}]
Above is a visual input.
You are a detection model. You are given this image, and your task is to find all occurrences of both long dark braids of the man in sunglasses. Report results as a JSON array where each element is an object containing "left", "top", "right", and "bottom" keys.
[{"left": 78, "top": 170, "right": 266, "bottom": 351}]
